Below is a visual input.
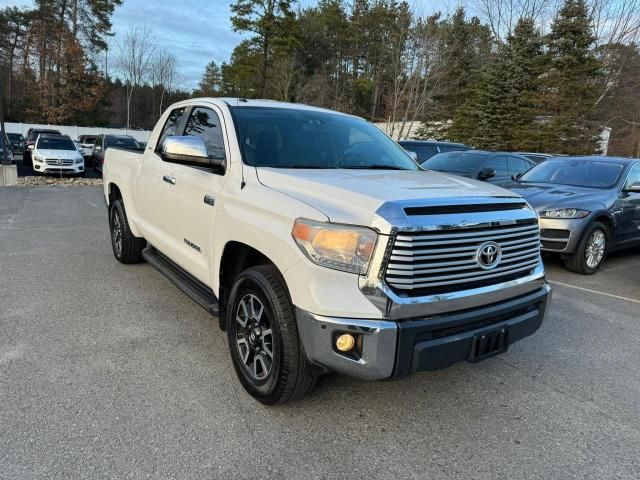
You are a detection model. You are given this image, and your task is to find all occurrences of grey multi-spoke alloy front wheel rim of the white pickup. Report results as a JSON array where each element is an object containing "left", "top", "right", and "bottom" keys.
[{"left": 235, "top": 293, "right": 273, "bottom": 381}]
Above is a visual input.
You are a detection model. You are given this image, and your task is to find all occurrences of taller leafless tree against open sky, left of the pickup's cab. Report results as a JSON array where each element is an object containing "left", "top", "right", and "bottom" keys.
[{"left": 117, "top": 24, "right": 155, "bottom": 128}]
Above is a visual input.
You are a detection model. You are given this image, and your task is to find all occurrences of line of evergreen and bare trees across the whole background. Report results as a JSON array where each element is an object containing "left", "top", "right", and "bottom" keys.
[{"left": 0, "top": 0, "right": 640, "bottom": 156}]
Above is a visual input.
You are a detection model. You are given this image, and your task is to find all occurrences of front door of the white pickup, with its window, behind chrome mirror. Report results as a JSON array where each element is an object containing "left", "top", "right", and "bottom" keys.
[{"left": 165, "top": 106, "right": 228, "bottom": 283}]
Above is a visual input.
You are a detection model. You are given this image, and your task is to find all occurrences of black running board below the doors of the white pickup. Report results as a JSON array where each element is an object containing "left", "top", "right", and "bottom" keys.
[{"left": 142, "top": 245, "right": 220, "bottom": 316}]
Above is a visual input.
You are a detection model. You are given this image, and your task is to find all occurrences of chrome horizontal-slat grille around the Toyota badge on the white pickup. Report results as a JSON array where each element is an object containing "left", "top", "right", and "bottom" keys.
[{"left": 385, "top": 220, "right": 540, "bottom": 295}]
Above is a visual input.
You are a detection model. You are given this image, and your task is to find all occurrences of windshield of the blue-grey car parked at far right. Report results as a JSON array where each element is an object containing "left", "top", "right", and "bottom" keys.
[{"left": 519, "top": 159, "right": 624, "bottom": 188}]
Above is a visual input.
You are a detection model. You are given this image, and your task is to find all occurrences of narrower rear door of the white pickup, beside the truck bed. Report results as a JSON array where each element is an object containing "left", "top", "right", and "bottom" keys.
[{"left": 135, "top": 107, "right": 186, "bottom": 259}]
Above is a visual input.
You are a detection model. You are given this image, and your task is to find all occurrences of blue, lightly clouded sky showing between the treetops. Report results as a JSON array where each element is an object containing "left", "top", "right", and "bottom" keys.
[{"left": 6, "top": 0, "right": 456, "bottom": 89}]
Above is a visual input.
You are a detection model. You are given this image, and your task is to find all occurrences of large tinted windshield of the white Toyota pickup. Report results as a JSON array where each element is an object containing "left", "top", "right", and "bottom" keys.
[{"left": 231, "top": 107, "right": 420, "bottom": 171}]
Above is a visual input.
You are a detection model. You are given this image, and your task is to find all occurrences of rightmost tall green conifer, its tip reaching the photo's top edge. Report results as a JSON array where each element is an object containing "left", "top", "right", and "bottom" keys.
[{"left": 543, "top": 0, "right": 601, "bottom": 154}]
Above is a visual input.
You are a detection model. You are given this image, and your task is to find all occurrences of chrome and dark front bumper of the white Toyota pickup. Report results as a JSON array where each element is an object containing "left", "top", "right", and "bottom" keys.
[{"left": 296, "top": 284, "right": 551, "bottom": 380}]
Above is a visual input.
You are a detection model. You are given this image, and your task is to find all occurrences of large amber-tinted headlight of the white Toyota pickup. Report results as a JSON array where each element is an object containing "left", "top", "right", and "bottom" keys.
[{"left": 291, "top": 218, "right": 378, "bottom": 274}]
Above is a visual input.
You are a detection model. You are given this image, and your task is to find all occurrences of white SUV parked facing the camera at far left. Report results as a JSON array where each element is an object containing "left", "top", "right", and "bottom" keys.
[{"left": 32, "top": 134, "right": 85, "bottom": 177}]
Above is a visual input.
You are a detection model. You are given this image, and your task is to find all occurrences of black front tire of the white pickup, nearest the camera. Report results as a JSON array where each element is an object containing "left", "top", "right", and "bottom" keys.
[{"left": 226, "top": 265, "right": 318, "bottom": 405}]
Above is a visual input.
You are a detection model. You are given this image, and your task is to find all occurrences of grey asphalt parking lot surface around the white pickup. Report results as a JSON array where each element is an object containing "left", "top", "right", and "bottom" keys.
[{"left": 0, "top": 187, "right": 640, "bottom": 479}]
